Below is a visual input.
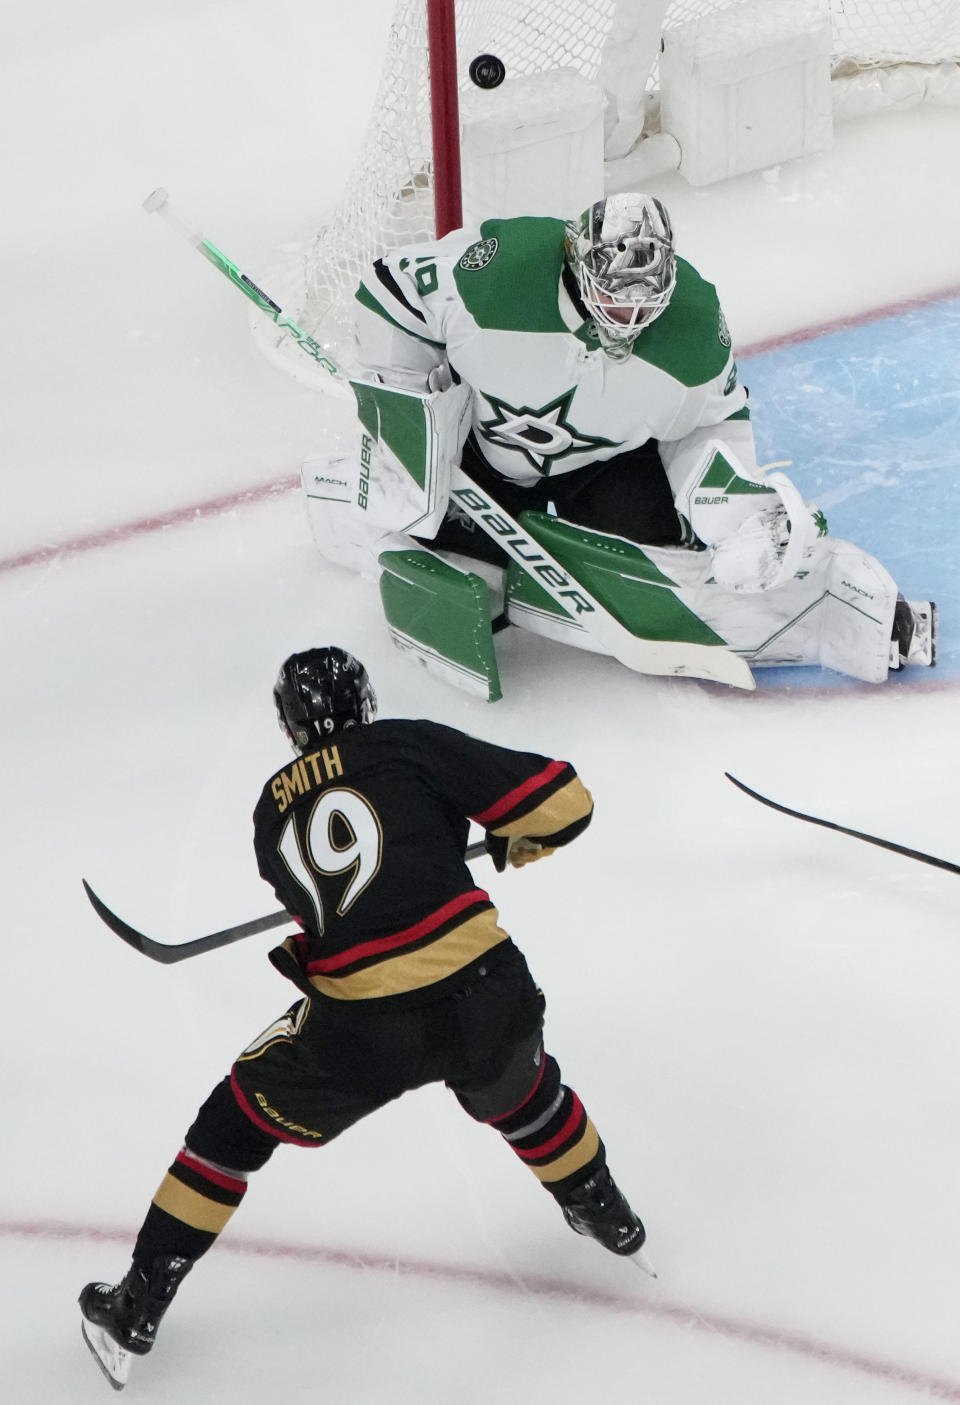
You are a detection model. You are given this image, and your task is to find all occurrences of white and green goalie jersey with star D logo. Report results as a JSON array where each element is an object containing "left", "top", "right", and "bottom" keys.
[{"left": 354, "top": 216, "right": 756, "bottom": 493}]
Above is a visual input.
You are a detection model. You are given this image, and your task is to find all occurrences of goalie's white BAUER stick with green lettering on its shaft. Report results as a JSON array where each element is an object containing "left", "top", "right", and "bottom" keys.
[{"left": 143, "top": 187, "right": 756, "bottom": 688}]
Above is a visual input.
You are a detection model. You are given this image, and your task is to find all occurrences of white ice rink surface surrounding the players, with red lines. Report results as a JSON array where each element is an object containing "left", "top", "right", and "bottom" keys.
[{"left": 0, "top": 0, "right": 960, "bottom": 1405}]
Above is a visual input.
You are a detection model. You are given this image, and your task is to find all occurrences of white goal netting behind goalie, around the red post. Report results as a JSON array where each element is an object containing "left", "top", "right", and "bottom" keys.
[{"left": 253, "top": 0, "right": 960, "bottom": 388}]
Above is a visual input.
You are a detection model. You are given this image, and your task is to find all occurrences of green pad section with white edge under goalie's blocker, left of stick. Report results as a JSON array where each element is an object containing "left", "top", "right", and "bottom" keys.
[{"left": 380, "top": 551, "right": 503, "bottom": 703}]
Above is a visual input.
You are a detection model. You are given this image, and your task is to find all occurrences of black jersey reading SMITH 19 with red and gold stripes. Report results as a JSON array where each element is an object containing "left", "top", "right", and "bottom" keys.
[{"left": 253, "top": 719, "right": 593, "bottom": 1000}]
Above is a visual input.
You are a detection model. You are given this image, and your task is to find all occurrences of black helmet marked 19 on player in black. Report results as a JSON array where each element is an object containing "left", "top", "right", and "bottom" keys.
[{"left": 273, "top": 648, "right": 377, "bottom": 753}]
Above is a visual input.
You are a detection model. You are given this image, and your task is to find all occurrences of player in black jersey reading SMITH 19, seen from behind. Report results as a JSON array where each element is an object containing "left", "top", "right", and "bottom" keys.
[{"left": 80, "top": 648, "right": 645, "bottom": 1390}]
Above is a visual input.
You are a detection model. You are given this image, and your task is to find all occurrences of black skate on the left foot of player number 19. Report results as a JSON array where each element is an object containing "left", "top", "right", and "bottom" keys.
[{"left": 79, "top": 1253, "right": 193, "bottom": 1391}]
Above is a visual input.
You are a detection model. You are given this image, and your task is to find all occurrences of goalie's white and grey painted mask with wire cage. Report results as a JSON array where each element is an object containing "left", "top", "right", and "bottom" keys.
[{"left": 565, "top": 195, "right": 676, "bottom": 361}]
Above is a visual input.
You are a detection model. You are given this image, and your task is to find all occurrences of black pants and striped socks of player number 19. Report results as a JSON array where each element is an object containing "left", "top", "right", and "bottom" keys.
[{"left": 134, "top": 941, "right": 606, "bottom": 1266}]
